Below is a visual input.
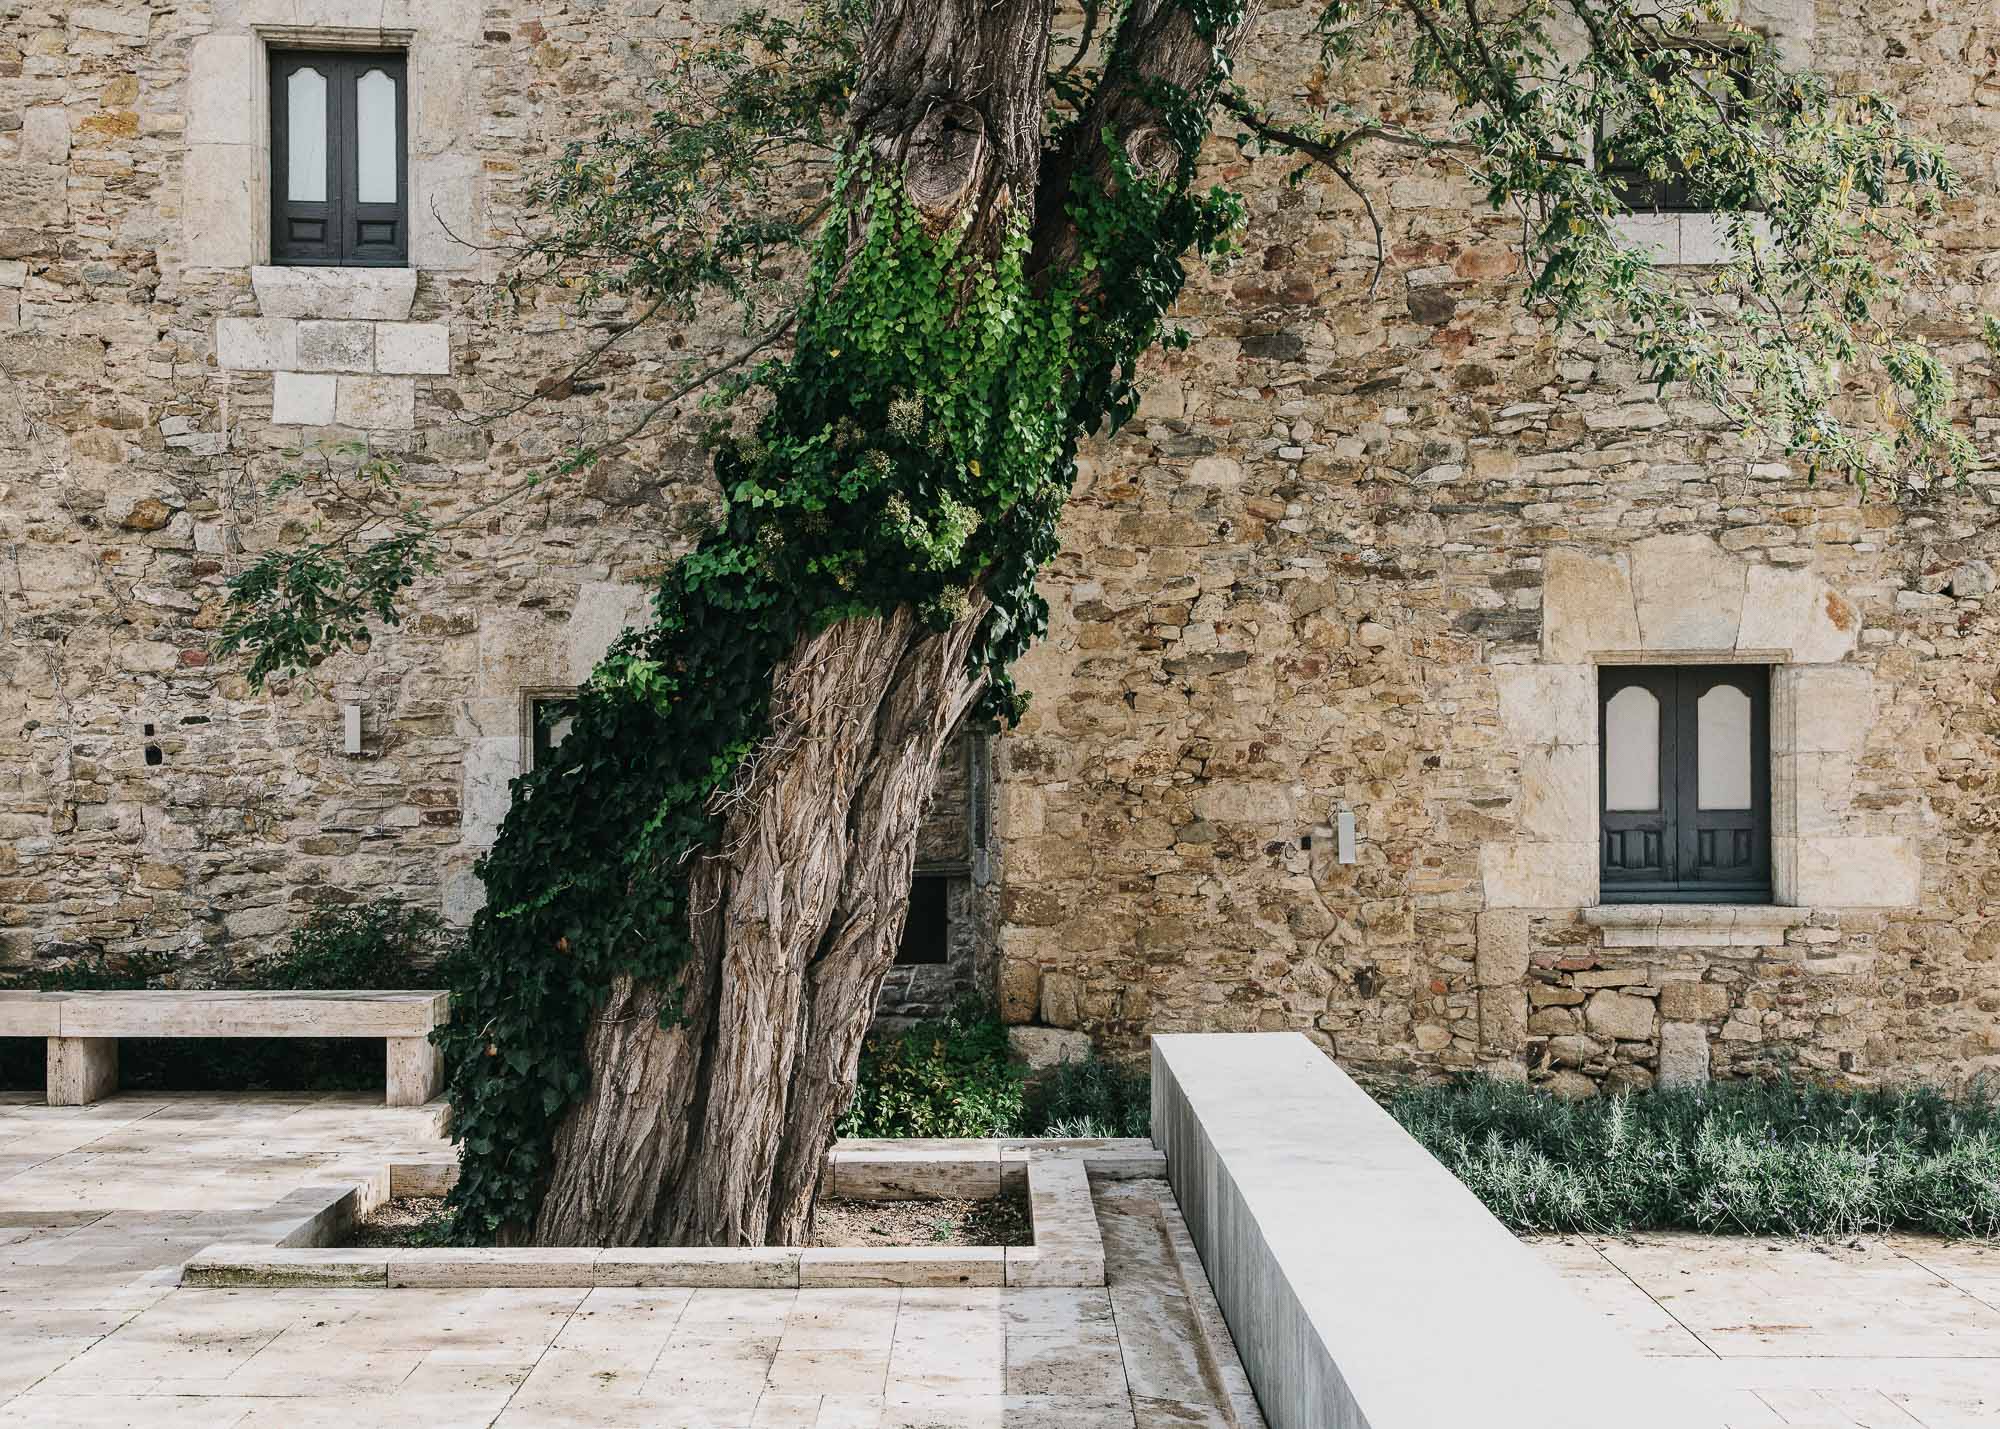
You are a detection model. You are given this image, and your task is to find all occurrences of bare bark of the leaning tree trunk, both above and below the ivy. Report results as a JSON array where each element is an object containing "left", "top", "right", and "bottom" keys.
[{"left": 532, "top": 0, "right": 1240, "bottom": 1245}]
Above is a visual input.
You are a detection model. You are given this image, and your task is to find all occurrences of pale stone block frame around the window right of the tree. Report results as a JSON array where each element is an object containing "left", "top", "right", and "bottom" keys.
[{"left": 1478, "top": 534, "right": 1922, "bottom": 928}]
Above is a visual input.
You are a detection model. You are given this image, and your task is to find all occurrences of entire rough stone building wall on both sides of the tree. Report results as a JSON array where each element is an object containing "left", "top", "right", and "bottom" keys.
[{"left": 0, "top": 0, "right": 2000, "bottom": 1095}]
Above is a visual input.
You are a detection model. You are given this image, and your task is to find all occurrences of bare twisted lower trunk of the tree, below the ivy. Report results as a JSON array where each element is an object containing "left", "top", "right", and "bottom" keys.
[{"left": 534, "top": 604, "right": 984, "bottom": 1245}]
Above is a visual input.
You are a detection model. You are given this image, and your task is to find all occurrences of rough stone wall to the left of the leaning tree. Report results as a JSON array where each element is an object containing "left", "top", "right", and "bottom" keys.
[{"left": 0, "top": 0, "right": 752, "bottom": 979}]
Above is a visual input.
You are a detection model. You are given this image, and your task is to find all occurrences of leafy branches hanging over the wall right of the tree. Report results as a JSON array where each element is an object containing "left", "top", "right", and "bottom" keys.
[{"left": 1228, "top": 0, "right": 1974, "bottom": 486}]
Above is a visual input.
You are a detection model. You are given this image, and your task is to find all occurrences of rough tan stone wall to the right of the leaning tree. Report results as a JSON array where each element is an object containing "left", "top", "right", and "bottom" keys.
[{"left": 996, "top": 4, "right": 2000, "bottom": 1093}]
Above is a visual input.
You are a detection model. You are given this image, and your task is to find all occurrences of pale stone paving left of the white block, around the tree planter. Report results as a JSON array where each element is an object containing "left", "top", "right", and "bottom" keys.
[{"left": 0, "top": 1097, "right": 1258, "bottom": 1429}]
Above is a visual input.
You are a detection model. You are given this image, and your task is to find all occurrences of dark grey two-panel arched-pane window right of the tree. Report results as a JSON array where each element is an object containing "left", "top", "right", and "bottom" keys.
[{"left": 1598, "top": 664, "right": 1772, "bottom": 903}]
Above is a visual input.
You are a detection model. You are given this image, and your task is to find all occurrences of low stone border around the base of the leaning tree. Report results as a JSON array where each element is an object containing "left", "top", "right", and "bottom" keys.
[{"left": 180, "top": 1141, "right": 1162, "bottom": 1289}]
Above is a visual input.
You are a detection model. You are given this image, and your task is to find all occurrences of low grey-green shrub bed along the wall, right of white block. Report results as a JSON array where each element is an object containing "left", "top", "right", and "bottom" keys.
[{"left": 1386, "top": 1079, "right": 2000, "bottom": 1237}]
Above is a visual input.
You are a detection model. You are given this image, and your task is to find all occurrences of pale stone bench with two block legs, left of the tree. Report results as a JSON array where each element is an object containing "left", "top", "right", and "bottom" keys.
[{"left": 0, "top": 991, "right": 452, "bottom": 1107}]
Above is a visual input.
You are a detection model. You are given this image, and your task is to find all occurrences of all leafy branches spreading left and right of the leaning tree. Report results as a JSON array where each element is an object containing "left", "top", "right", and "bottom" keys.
[{"left": 222, "top": 0, "right": 1976, "bottom": 680}]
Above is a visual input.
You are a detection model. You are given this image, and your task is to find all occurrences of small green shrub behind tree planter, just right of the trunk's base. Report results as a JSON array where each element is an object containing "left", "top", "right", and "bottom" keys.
[{"left": 840, "top": 1005, "right": 1026, "bottom": 1137}]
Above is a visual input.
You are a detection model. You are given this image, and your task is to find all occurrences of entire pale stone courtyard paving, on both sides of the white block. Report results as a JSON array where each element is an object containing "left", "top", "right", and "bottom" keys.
[{"left": 0, "top": 1093, "right": 2000, "bottom": 1429}]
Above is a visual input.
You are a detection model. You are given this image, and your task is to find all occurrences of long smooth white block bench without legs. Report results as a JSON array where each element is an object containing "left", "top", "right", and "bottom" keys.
[{"left": 1152, "top": 1033, "right": 1722, "bottom": 1429}]
